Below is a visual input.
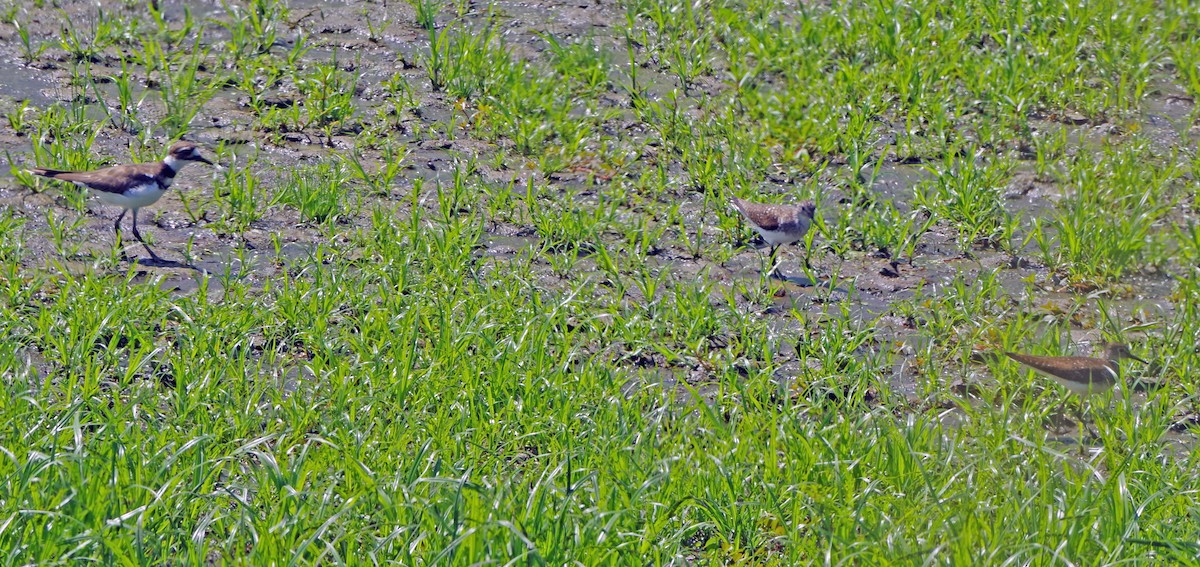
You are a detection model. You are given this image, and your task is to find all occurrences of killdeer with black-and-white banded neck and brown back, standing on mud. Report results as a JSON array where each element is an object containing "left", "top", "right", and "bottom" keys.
[{"left": 29, "top": 142, "right": 212, "bottom": 261}]
